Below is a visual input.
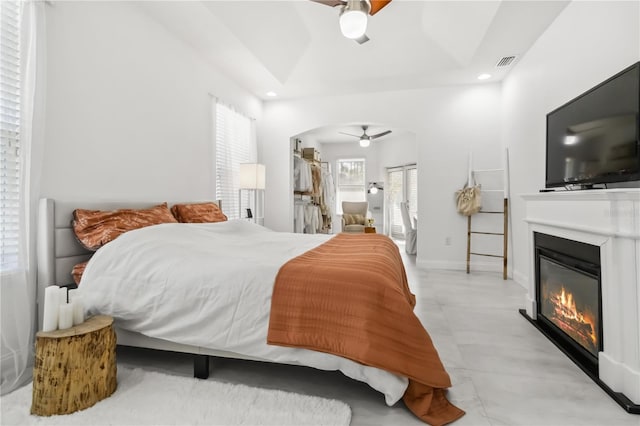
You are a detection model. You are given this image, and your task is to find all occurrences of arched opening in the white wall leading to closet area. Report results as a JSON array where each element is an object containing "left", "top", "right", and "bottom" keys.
[{"left": 290, "top": 123, "right": 417, "bottom": 236}]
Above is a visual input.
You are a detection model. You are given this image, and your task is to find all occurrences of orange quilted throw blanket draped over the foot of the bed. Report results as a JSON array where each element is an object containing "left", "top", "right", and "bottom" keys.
[{"left": 267, "top": 234, "right": 464, "bottom": 425}]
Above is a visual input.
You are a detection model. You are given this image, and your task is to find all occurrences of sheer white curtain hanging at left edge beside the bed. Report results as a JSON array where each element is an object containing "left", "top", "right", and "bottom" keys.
[{"left": 0, "top": 0, "right": 45, "bottom": 394}]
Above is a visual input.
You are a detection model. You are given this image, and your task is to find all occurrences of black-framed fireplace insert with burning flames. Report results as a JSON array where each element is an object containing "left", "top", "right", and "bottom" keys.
[{"left": 534, "top": 232, "right": 602, "bottom": 377}]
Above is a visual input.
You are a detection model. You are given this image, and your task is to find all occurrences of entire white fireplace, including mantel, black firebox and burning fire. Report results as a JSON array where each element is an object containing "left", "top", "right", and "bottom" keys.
[{"left": 524, "top": 188, "right": 640, "bottom": 414}]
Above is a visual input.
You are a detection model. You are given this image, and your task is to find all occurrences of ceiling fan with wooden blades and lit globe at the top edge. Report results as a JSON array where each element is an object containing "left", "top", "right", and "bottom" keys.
[{"left": 311, "top": 0, "right": 391, "bottom": 44}]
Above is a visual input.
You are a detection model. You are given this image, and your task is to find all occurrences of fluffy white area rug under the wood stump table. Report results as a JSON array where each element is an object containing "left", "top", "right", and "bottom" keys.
[{"left": 0, "top": 367, "right": 351, "bottom": 426}]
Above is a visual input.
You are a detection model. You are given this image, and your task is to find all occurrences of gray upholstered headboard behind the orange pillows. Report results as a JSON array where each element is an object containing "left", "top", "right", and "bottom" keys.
[{"left": 37, "top": 198, "right": 220, "bottom": 329}]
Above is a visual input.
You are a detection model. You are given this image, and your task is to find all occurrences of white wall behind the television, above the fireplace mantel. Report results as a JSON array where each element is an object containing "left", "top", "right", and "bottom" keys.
[{"left": 502, "top": 1, "right": 640, "bottom": 286}]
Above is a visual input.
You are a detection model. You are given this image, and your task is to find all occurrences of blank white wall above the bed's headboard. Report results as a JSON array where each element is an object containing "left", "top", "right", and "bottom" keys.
[{"left": 41, "top": 1, "right": 262, "bottom": 200}]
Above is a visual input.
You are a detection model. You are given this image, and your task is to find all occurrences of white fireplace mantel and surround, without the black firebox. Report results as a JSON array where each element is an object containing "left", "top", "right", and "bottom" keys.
[{"left": 522, "top": 188, "right": 640, "bottom": 404}]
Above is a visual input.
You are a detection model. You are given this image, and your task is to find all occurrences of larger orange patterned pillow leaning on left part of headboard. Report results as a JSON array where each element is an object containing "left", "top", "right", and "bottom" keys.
[{"left": 72, "top": 203, "right": 177, "bottom": 251}]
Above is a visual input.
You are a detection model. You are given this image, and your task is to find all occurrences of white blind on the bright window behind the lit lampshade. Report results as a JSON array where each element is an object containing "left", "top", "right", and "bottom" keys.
[{"left": 214, "top": 100, "right": 257, "bottom": 219}]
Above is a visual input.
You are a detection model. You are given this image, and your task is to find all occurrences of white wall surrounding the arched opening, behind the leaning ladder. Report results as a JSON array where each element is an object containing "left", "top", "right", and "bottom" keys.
[{"left": 258, "top": 84, "right": 501, "bottom": 268}]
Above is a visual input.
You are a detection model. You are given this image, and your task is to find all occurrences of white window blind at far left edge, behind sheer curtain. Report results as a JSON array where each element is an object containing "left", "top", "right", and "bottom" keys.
[{"left": 0, "top": 0, "right": 21, "bottom": 272}]
